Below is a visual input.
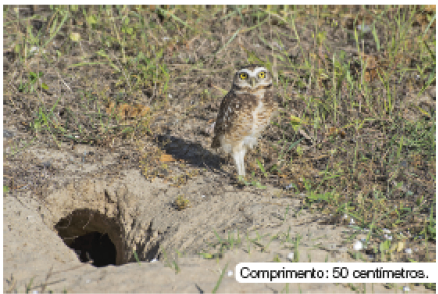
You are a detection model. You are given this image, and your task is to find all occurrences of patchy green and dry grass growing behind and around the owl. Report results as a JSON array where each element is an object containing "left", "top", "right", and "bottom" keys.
[{"left": 3, "top": 5, "right": 436, "bottom": 272}]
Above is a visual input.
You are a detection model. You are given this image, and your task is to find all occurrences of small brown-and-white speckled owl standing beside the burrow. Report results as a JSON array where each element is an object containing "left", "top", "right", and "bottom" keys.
[{"left": 211, "top": 65, "right": 277, "bottom": 176}]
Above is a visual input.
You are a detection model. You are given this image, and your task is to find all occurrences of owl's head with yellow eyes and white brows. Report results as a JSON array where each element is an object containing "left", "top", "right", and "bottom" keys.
[{"left": 233, "top": 64, "right": 272, "bottom": 92}]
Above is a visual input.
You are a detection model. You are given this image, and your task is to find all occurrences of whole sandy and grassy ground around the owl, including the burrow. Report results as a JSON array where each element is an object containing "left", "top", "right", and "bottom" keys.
[{"left": 3, "top": 6, "right": 436, "bottom": 293}]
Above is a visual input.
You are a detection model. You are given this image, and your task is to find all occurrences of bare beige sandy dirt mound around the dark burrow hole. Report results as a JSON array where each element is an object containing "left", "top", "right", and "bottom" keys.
[{"left": 3, "top": 165, "right": 427, "bottom": 293}]
